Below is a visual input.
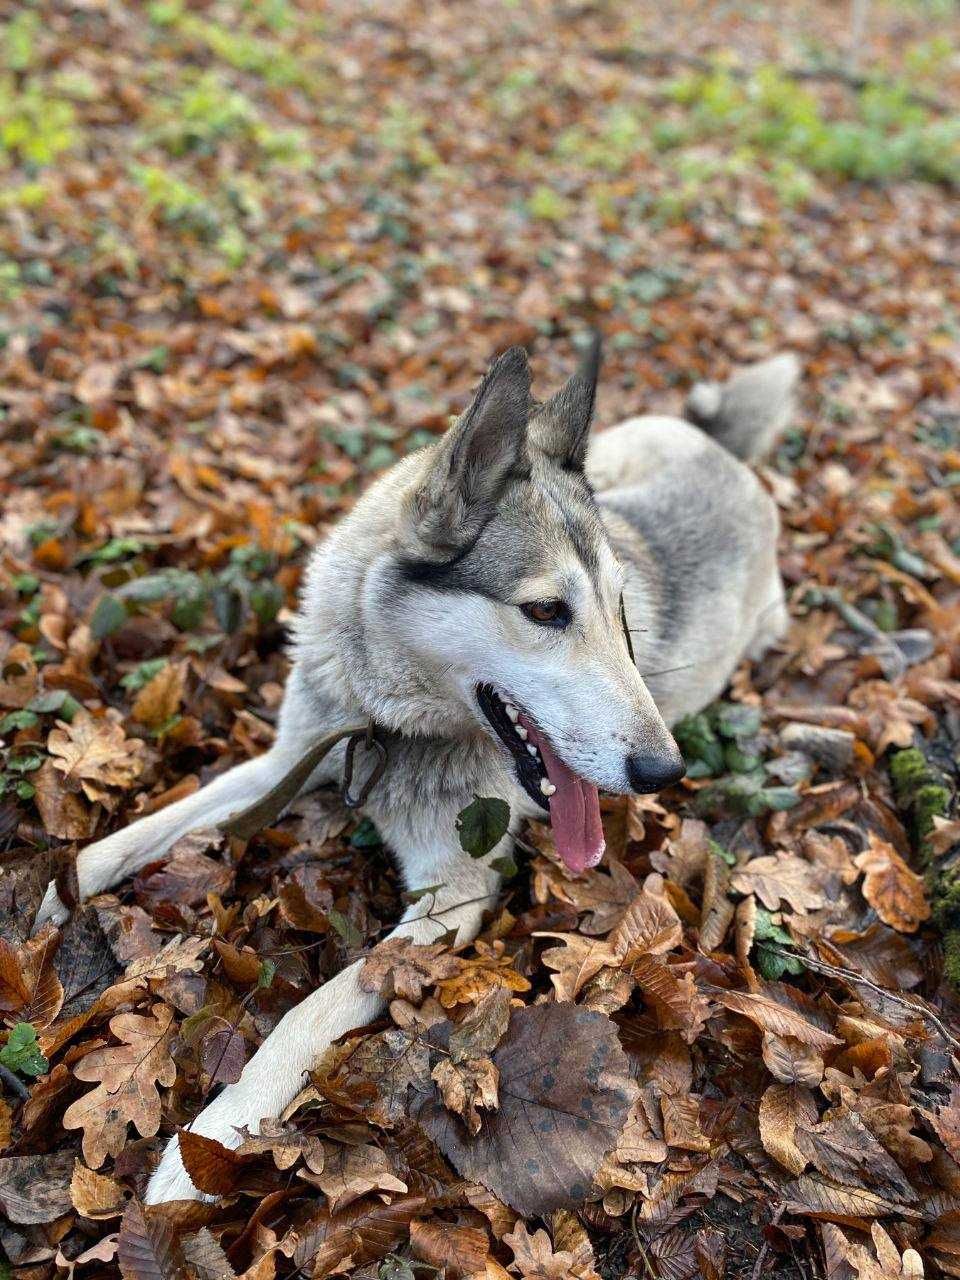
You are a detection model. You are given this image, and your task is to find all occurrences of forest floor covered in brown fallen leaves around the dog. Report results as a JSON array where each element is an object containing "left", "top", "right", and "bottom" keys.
[{"left": 0, "top": 0, "right": 960, "bottom": 1280}]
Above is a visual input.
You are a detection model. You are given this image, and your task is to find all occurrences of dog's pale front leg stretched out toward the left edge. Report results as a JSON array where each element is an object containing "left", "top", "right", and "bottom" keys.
[{"left": 37, "top": 669, "right": 323, "bottom": 925}]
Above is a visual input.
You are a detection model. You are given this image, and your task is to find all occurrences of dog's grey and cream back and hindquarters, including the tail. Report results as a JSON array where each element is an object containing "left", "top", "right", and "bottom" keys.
[{"left": 586, "top": 355, "right": 799, "bottom": 723}]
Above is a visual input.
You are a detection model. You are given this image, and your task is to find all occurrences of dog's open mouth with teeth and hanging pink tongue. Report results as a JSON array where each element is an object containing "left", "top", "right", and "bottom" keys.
[{"left": 476, "top": 685, "right": 604, "bottom": 872}]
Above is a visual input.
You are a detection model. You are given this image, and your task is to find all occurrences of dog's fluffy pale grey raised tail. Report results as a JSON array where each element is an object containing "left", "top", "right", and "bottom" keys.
[{"left": 684, "top": 352, "right": 800, "bottom": 462}]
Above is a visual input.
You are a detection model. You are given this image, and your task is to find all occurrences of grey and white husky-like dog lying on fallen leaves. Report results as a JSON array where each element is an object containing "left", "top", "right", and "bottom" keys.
[{"left": 38, "top": 342, "right": 797, "bottom": 1203}]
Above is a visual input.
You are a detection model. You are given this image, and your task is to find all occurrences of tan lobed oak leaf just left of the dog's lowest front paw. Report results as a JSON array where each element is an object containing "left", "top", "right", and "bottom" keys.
[{"left": 63, "top": 1005, "right": 177, "bottom": 1169}]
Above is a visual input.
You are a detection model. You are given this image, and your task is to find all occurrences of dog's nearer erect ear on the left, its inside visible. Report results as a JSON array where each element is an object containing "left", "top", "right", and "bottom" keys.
[{"left": 413, "top": 347, "right": 531, "bottom": 552}]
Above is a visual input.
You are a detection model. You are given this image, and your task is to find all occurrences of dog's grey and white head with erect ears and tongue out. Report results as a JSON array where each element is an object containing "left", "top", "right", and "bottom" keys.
[{"left": 368, "top": 344, "right": 684, "bottom": 869}]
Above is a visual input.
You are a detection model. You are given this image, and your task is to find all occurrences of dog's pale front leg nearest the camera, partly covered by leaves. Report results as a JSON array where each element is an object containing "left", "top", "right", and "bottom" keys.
[{"left": 146, "top": 837, "right": 509, "bottom": 1204}]
